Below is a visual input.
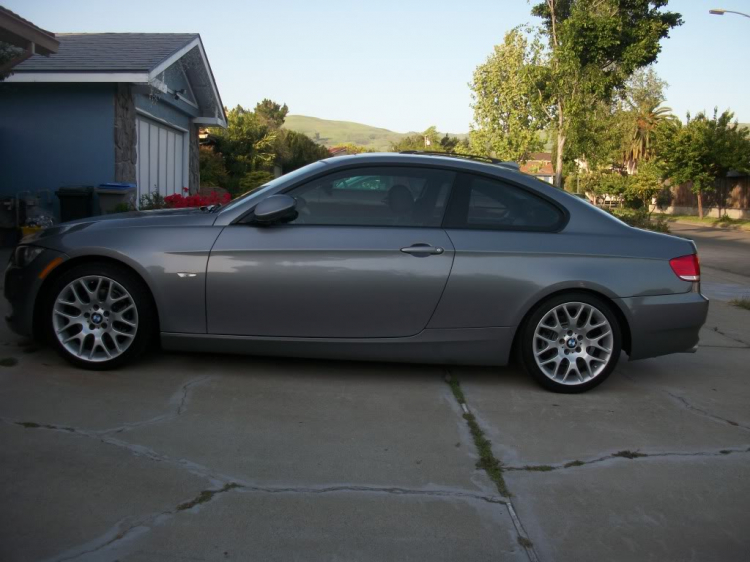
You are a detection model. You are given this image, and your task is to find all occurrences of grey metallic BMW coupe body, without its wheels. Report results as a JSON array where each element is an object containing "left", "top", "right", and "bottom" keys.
[{"left": 6, "top": 154, "right": 708, "bottom": 391}]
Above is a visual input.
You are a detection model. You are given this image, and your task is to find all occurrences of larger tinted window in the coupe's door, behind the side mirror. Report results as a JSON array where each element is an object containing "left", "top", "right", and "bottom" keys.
[{"left": 288, "top": 167, "right": 455, "bottom": 227}]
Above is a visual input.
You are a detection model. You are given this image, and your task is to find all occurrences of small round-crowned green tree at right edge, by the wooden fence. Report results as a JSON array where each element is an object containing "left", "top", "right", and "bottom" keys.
[{"left": 657, "top": 109, "right": 750, "bottom": 218}]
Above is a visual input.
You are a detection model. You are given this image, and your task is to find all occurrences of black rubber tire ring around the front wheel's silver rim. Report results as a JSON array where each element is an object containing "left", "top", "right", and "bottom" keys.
[{"left": 43, "top": 262, "right": 156, "bottom": 371}]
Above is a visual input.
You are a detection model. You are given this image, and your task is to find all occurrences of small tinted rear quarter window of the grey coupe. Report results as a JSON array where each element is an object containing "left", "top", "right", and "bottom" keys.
[{"left": 447, "top": 175, "right": 565, "bottom": 231}]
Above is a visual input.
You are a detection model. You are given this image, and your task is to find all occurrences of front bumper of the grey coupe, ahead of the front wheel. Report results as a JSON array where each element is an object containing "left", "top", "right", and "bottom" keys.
[{"left": 4, "top": 249, "right": 68, "bottom": 337}]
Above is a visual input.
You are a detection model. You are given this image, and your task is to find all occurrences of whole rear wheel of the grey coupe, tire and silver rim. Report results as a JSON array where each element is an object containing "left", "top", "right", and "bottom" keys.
[{"left": 519, "top": 292, "right": 622, "bottom": 394}]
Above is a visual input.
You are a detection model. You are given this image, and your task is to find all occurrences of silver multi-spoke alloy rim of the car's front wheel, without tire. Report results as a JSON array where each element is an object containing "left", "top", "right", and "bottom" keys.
[{"left": 52, "top": 275, "right": 138, "bottom": 362}]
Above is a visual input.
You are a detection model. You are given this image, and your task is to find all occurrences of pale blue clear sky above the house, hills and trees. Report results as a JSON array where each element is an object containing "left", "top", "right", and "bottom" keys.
[{"left": 7, "top": 0, "right": 750, "bottom": 133}]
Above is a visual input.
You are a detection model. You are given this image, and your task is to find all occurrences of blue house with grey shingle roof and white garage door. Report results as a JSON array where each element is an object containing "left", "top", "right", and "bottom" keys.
[{"left": 0, "top": 33, "right": 226, "bottom": 213}]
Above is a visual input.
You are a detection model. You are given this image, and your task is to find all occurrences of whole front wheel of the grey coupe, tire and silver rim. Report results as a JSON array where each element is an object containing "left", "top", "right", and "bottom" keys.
[{"left": 44, "top": 262, "right": 158, "bottom": 371}]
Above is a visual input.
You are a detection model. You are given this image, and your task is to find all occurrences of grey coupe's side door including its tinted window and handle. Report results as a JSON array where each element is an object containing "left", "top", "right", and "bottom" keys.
[{"left": 206, "top": 166, "right": 455, "bottom": 338}]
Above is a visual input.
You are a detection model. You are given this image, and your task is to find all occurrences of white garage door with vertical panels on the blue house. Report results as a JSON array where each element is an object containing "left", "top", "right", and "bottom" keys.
[{"left": 137, "top": 116, "right": 188, "bottom": 199}]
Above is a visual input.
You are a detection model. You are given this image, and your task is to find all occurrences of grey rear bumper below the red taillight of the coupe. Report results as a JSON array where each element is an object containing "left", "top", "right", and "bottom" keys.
[{"left": 616, "top": 292, "right": 708, "bottom": 360}]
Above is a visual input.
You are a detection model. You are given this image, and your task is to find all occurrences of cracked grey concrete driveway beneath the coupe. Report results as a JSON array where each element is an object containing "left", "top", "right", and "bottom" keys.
[{"left": 0, "top": 234, "right": 750, "bottom": 562}]
